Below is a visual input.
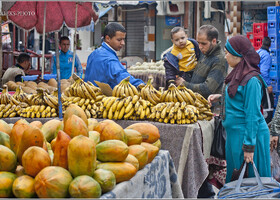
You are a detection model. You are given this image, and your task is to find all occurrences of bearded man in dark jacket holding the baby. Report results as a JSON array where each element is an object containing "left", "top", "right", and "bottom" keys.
[{"left": 176, "top": 25, "right": 228, "bottom": 99}]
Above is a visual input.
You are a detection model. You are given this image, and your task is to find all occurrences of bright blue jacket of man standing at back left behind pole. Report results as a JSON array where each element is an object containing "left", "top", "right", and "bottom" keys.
[{"left": 52, "top": 50, "right": 83, "bottom": 79}]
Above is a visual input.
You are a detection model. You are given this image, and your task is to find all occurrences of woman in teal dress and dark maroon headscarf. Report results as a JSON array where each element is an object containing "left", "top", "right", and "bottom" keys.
[{"left": 208, "top": 35, "right": 271, "bottom": 182}]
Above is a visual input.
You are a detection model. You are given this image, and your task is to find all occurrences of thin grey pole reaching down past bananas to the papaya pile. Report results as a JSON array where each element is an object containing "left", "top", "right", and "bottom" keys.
[{"left": 55, "top": 32, "right": 62, "bottom": 119}]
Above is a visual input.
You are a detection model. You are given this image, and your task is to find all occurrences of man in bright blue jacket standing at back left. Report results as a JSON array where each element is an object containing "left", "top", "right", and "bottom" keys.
[{"left": 52, "top": 36, "right": 83, "bottom": 79}]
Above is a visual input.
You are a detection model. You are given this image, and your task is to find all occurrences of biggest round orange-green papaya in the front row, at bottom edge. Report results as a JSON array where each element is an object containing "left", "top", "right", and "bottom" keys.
[{"left": 34, "top": 166, "right": 73, "bottom": 198}]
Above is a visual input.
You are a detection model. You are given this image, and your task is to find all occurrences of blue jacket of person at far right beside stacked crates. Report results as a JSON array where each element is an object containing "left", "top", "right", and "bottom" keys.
[{"left": 257, "top": 48, "right": 272, "bottom": 86}]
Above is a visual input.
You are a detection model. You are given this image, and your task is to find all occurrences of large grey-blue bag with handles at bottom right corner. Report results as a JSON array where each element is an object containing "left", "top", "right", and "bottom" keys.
[{"left": 218, "top": 163, "right": 280, "bottom": 199}]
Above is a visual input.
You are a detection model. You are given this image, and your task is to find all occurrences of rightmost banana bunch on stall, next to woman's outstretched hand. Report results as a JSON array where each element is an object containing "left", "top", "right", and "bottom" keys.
[{"left": 194, "top": 93, "right": 213, "bottom": 121}]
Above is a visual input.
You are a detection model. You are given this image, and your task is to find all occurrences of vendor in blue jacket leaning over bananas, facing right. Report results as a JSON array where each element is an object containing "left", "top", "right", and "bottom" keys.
[{"left": 85, "top": 22, "right": 144, "bottom": 89}]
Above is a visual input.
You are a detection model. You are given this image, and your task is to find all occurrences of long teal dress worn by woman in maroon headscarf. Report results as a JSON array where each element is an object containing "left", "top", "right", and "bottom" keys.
[{"left": 223, "top": 77, "right": 271, "bottom": 182}]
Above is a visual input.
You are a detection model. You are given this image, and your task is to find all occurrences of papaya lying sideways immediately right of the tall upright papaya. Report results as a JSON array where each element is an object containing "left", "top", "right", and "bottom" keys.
[{"left": 96, "top": 140, "right": 128, "bottom": 162}]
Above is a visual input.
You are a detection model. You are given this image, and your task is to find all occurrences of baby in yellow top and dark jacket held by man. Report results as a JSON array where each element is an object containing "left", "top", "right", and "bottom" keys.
[{"left": 161, "top": 26, "right": 200, "bottom": 88}]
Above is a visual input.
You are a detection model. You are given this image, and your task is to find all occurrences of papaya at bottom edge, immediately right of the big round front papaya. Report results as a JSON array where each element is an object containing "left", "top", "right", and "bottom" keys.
[{"left": 69, "top": 175, "right": 102, "bottom": 198}]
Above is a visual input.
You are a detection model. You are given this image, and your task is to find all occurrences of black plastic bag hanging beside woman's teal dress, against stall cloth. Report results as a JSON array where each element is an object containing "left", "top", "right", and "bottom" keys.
[{"left": 210, "top": 116, "right": 226, "bottom": 160}]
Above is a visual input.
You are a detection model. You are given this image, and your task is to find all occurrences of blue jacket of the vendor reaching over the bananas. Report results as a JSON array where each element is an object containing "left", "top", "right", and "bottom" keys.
[{"left": 85, "top": 42, "right": 144, "bottom": 88}]
